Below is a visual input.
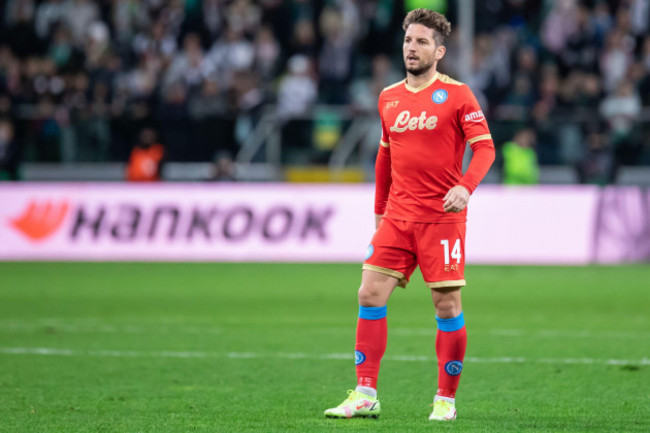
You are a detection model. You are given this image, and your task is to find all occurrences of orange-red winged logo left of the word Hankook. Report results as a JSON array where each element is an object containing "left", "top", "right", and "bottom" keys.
[{"left": 11, "top": 200, "right": 69, "bottom": 241}]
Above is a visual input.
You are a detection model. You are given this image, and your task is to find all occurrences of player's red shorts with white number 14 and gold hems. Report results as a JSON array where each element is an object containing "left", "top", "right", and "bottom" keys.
[{"left": 363, "top": 218, "right": 465, "bottom": 289}]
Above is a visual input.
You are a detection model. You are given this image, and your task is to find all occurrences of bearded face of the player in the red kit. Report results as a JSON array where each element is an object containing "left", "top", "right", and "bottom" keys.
[{"left": 402, "top": 24, "right": 445, "bottom": 75}]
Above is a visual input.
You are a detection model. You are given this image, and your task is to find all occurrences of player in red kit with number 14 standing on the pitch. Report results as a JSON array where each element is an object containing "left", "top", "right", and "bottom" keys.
[{"left": 325, "top": 9, "right": 494, "bottom": 421}]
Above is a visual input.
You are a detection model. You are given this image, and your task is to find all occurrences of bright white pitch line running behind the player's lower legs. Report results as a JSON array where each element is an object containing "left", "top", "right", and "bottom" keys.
[{"left": 0, "top": 347, "right": 650, "bottom": 365}]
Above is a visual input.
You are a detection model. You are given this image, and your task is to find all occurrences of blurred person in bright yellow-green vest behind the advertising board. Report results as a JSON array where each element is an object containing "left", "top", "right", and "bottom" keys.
[{"left": 501, "top": 128, "right": 539, "bottom": 185}]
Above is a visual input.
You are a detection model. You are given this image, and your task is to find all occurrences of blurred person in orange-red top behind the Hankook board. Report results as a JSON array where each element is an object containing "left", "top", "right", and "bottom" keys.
[{"left": 126, "top": 127, "right": 165, "bottom": 182}]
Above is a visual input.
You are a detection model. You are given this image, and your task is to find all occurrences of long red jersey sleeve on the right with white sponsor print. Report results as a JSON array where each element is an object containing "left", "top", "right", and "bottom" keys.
[{"left": 458, "top": 86, "right": 495, "bottom": 194}]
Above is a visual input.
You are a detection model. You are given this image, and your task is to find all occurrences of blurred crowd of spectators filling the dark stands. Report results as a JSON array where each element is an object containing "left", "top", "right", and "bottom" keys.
[{"left": 0, "top": 0, "right": 650, "bottom": 182}]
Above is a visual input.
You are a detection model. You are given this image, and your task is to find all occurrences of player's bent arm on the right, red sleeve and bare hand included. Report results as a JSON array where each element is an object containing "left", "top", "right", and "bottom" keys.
[{"left": 443, "top": 86, "right": 495, "bottom": 212}]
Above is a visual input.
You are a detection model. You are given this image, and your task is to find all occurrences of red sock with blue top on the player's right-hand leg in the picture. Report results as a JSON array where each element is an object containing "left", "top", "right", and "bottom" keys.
[{"left": 436, "top": 313, "right": 467, "bottom": 398}]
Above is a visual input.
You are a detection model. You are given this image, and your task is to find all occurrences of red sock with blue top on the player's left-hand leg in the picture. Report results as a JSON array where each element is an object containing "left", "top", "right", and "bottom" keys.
[{"left": 354, "top": 306, "right": 388, "bottom": 389}]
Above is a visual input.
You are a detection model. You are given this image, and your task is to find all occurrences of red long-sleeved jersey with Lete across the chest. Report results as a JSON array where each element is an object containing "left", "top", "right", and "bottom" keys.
[{"left": 375, "top": 72, "right": 494, "bottom": 223}]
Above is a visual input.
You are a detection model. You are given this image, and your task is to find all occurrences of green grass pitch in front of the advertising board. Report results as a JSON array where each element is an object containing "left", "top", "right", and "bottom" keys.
[{"left": 0, "top": 263, "right": 650, "bottom": 433}]
